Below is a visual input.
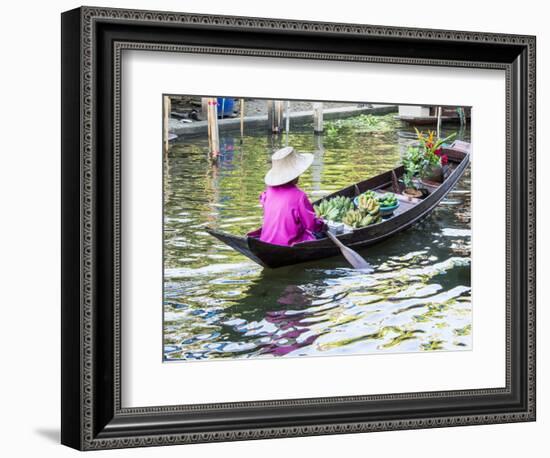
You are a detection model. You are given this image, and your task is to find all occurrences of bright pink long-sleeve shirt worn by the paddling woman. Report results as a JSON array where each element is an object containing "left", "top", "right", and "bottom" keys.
[{"left": 248, "top": 183, "right": 324, "bottom": 246}]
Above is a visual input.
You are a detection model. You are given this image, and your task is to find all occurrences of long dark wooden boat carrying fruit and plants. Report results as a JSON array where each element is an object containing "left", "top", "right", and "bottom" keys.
[{"left": 208, "top": 142, "right": 470, "bottom": 268}]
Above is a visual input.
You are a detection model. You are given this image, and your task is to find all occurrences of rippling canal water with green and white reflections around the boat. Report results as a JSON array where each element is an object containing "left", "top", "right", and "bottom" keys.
[{"left": 163, "top": 114, "right": 472, "bottom": 361}]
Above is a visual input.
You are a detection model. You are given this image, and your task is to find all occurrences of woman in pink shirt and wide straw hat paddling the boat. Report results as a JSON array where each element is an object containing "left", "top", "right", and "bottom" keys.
[{"left": 248, "top": 146, "right": 325, "bottom": 246}]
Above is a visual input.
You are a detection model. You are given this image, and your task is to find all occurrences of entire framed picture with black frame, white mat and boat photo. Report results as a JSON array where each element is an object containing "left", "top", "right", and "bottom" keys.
[{"left": 61, "top": 7, "right": 536, "bottom": 450}]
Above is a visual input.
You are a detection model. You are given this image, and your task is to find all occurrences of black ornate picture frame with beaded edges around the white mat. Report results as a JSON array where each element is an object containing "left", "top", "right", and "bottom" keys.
[{"left": 61, "top": 7, "right": 536, "bottom": 450}]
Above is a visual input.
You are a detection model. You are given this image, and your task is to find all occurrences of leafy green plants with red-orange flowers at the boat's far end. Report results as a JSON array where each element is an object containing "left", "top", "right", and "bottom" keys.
[{"left": 403, "top": 128, "right": 456, "bottom": 197}]
